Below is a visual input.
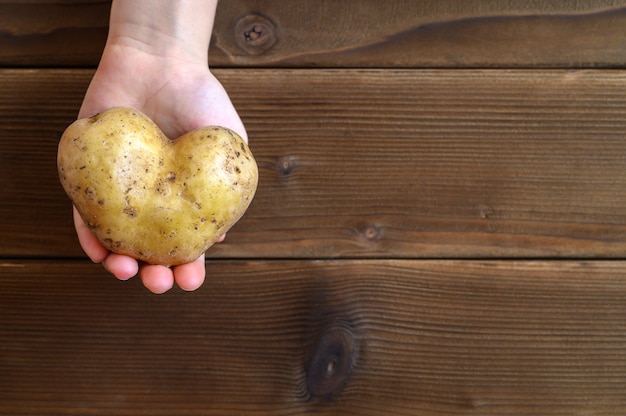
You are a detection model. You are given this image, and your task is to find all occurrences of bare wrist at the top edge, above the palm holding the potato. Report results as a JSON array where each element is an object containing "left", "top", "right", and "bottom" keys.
[{"left": 107, "top": 0, "right": 217, "bottom": 65}]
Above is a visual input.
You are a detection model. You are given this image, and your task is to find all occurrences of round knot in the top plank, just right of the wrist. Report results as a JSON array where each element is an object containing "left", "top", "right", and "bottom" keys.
[{"left": 235, "top": 13, "right": 277, "bottom": 55}]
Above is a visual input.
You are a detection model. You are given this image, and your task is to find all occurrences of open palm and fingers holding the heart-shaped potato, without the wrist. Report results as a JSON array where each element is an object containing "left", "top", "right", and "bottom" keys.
[{"left": 74, "top": 45, "right": 247, "bottom": 293}]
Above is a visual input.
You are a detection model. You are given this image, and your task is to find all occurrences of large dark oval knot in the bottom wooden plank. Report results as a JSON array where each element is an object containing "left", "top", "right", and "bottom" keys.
[{"left": 306, "top": 327, "right": 358, "bottom": 397}]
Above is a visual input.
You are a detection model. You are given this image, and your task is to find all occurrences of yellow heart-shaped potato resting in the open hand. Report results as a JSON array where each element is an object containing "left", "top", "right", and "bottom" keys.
[{"left": 57, "top": 107, "right": 258, "bottom": 266}]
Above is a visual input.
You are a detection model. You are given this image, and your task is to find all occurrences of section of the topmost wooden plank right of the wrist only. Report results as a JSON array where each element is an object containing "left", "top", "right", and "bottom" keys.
[{"left": 210, "top": 0, "right": 626, "bottom": 68}]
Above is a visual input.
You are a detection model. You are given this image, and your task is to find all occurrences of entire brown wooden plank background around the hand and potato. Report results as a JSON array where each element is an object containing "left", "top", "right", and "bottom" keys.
[{"left": 0, "top": 0, "right": 626, "bottom": 415}]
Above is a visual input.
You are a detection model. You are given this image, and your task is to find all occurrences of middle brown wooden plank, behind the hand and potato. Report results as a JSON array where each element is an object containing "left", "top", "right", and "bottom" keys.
[{"left": 0, "top": 70, "right": 626, "bottom": 258}]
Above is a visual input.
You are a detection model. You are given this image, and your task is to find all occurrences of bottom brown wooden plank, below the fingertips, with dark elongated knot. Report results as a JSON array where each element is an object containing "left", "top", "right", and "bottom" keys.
[{"left": 0, "top": 260, "right": 626, "bottom": 416}]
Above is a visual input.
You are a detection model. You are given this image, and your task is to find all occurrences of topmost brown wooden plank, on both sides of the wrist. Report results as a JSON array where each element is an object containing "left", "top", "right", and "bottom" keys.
[{"left": 0, "top": 0, "right": 626, "bottom": 68}]
